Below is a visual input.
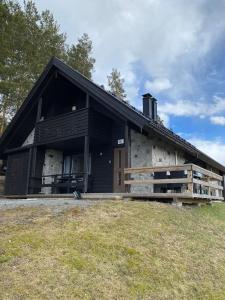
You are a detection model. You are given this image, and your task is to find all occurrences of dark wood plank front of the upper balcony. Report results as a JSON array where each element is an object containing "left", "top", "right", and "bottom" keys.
[{"left": 35, "top": 109, "right": 88, "bottom": 145}]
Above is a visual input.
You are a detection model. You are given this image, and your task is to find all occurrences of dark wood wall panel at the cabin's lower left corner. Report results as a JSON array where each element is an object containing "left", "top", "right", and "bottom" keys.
[{"left": 5, "top": 150, "right": 29, "bottom": 195}]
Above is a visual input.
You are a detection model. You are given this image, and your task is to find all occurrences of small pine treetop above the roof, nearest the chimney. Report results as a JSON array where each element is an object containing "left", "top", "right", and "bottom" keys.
[{"left": 107, "top": 69, "right": 127, "bottom": 100}]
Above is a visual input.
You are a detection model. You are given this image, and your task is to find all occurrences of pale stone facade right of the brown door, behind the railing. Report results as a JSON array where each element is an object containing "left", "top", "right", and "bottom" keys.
[{"left": 130, "top": 130, "right": 185, "bottom": 193}]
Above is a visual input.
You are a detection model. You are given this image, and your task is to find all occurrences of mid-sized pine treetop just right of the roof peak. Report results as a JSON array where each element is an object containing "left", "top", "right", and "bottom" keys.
[{"left": 67, "top": 33, "right": 95, "bottom": 79}]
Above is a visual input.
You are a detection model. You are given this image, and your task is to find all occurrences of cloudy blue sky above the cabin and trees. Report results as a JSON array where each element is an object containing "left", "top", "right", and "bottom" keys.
[{"left": 22, "top": 0, "right": 225, "bottom": 165}]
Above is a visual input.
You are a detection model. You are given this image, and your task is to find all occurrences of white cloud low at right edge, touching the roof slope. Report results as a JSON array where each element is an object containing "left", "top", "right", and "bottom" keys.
[{"left": 188, "top": 138, "right": 225, "bottom": 166}]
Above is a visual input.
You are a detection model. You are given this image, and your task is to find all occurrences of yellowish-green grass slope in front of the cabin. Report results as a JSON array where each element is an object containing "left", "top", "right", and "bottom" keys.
[{"left": 0, "top": 201, "right": 225, "bottom": 300}]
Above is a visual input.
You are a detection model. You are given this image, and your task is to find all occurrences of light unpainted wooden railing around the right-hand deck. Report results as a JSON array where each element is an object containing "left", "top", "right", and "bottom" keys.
[{"left": 124, "top": 164, "right": 224, "bottom": 200}]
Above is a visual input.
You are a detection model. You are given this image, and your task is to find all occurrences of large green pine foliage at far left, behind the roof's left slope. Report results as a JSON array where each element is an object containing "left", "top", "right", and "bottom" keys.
[{"left": 0, "top": 0, "right": 65, "bottom": 132}]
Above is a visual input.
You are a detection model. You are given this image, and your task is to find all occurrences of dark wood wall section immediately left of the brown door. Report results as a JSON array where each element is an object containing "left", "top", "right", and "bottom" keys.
[{"left": 91, "top": 145, "right": 113, "bottom": 193}]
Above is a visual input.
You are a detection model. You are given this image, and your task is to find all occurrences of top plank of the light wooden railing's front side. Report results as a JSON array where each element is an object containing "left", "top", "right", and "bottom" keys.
[{"left": 124, "top": 164, "right": 191, "bottom": 174}]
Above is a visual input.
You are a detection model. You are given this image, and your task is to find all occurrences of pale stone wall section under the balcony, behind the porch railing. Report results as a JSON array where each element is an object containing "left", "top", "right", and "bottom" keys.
[{"left": 41, "top": 149, "right": 63, "bottom": 194}]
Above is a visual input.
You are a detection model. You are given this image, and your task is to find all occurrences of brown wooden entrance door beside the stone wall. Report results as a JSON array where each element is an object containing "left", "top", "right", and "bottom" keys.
[{"left": 113, "top": 148, "right": 125, "bottom": 193}]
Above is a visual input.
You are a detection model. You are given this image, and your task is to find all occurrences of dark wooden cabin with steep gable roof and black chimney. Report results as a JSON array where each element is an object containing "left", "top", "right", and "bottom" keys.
[{"left": 0, "top": 58, "right": 225, "bottom": 195}]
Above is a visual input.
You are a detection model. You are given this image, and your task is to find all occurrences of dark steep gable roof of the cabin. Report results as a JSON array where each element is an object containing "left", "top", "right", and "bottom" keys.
[{"left": 0, "top": 57, "right": 225, "bottom": 173}]
